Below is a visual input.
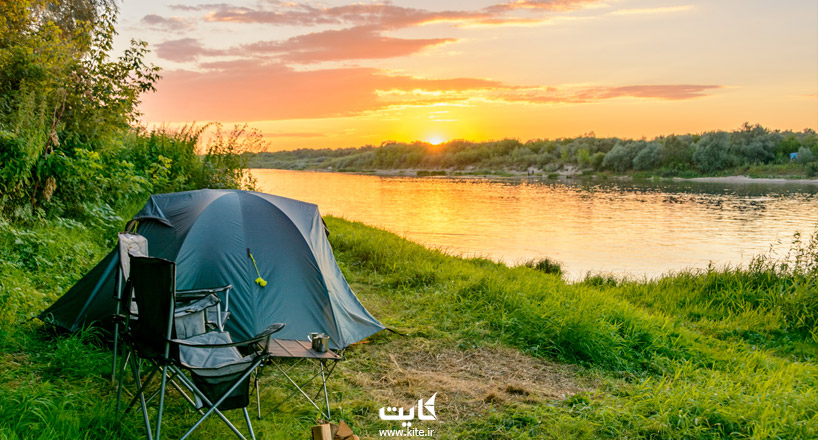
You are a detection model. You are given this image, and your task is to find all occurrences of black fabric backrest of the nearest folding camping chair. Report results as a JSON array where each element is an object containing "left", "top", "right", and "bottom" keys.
[{"left": 130, "top": 255, "right": 176, "bottom": 358}]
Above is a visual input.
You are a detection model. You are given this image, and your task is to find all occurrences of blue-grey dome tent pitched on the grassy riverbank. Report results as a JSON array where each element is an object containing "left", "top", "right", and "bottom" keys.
[{"left": 39, "top": 189, "right": 384, "bottom": 349}]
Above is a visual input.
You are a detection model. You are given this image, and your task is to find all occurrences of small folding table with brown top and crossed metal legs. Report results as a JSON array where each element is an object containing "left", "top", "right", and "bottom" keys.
[{"left": 255, "top": 339, "right": 344, "bottom": 420}]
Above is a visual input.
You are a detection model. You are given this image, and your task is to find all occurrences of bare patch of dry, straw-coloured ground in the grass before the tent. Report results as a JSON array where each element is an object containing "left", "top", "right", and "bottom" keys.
[{"left": 350, "top": 341, "right": 590, "bottom": 420}]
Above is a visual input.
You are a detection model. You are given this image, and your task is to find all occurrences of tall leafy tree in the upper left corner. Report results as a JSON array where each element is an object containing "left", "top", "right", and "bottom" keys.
[{"left": 0, "top": 0, "right": 159, "bottom": 216}]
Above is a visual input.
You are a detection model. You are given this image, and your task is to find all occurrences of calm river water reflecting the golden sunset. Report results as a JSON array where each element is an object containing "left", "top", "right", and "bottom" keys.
[{"left": 252, "top": 169, "right": 818, "bottom": 279}]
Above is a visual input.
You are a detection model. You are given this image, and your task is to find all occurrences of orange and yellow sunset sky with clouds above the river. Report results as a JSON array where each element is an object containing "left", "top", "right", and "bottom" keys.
[{"left": 115, "top": 0, "right": 818, "bottom": 151}]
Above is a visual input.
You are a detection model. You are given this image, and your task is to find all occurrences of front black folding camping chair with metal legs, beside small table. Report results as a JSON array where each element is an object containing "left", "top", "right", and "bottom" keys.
[{"left": 117, "top": 256, "right": 284, "bottom": 440}]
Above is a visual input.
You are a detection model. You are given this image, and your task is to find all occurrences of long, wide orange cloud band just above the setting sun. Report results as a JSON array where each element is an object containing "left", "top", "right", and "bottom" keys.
[{"left": 141, "top": 60, "right": 720, "bottom": 122}]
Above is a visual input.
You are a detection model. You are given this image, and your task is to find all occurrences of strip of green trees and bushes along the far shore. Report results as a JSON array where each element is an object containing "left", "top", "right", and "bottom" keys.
[{"left": 246, "top": 123, "right": 818, "bottom": 178}]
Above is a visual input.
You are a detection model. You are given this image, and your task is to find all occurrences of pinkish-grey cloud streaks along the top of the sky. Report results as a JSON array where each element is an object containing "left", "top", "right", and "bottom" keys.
[{"left": 155, "top": 0, "right": 599, "bottom": 64}]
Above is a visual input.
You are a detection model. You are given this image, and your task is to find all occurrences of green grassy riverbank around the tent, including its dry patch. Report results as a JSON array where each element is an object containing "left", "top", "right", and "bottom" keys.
[{"left": 0, "top": 212, "right": 818, "bottom": 439}]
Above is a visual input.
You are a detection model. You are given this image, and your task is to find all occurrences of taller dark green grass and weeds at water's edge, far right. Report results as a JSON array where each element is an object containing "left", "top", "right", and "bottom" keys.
[{"left": 611, "top": 229, "right": 818, "bottom": 358}]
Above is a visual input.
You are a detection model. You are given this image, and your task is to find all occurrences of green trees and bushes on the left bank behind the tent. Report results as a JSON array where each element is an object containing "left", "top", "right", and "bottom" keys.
[{"left": 0, "top": 0, "right": 255, "bottom": 225}]
